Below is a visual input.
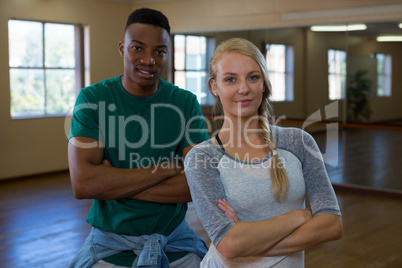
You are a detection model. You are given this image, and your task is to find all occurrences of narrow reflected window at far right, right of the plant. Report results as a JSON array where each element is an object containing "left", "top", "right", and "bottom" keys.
[{"left": 374, "top": 53, "right": 392, "bottom": 97}]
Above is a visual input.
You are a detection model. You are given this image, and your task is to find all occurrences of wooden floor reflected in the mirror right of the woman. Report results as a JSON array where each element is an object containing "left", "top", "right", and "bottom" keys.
[{"left": 312, "top": 127, "right": 402, "bottom": 194}]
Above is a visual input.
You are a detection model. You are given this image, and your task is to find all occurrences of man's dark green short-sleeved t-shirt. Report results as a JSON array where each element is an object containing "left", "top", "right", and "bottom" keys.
[{"left": 69, "top": 76, "right": 209, "bottom": 267}]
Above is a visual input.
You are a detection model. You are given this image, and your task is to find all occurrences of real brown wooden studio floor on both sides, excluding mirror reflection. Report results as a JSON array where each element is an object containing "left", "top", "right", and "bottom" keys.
[{"left": 0, "top": 172, "right": 402, "bottom": 268}]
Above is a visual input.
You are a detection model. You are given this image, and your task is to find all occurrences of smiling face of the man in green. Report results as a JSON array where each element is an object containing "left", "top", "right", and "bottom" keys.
[{"left": 119, "top": 23, "right": 170, "bottom": 95}]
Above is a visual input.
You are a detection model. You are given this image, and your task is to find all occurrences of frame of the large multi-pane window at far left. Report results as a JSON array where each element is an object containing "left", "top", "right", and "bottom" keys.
[{"left": 7, "top": 18, "right": 86, "bottom": 120}]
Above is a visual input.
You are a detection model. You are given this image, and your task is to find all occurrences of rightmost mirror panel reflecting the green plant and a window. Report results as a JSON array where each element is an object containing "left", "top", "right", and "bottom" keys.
[{"left": 339, "top": 21, "right": 402, "bottom": 193}]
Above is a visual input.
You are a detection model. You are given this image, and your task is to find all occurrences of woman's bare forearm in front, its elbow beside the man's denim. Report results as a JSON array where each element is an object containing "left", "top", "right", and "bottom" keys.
[{"left": 217, "top": 210, "right": 311, "bottom": 259}]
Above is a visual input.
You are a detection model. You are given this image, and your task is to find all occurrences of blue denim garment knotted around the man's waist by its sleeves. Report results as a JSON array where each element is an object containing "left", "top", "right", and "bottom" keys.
[{"left": 69, "top": 220, "right": 208, "bottom": 268}]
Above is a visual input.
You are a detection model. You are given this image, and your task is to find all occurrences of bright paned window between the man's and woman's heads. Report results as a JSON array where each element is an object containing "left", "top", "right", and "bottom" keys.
[{"left": 174, "top": 35, "right": 215, "bottom": 105}]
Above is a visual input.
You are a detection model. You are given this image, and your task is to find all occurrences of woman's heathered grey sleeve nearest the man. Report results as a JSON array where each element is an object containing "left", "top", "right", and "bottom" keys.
[{"left": 184, "top": 142, "right": 234, "bottom": 246}]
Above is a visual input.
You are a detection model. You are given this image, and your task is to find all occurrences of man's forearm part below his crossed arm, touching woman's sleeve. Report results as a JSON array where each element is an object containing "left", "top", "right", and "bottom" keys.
[{"left": 129, "top": 174, "right": 191, "bottom": 203}]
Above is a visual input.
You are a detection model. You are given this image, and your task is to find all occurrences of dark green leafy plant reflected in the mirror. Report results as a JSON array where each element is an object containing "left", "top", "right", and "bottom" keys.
[{"left": 346, "top": 70, "right": 372, "bottom": 122}]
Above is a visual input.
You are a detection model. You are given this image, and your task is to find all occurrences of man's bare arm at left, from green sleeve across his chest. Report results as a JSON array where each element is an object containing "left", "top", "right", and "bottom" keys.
[{"left": 68, "top": 137, "right": 183, "bottom": 199}]
